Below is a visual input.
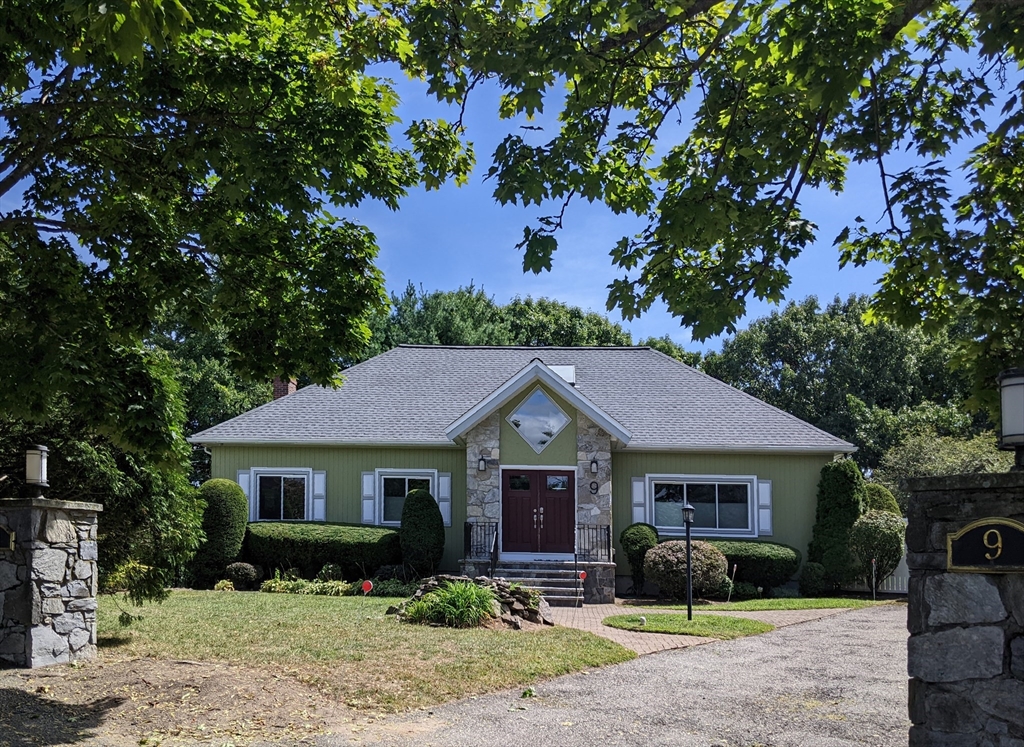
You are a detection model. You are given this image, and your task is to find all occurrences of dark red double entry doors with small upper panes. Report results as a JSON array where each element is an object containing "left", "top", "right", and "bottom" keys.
[{"left": 502, "top": 469, "right": 575, "bottom": 554}]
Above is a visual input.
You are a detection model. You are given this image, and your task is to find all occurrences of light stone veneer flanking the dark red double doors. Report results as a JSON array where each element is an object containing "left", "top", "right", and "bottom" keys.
[{"left": 463, "top": 412, "right": 615, "bottom": 604}]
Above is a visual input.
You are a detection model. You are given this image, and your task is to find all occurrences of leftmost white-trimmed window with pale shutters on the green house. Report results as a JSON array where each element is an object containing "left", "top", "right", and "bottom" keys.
[{"left": 238, "top": 467, "right": 327, "bottom": 522}]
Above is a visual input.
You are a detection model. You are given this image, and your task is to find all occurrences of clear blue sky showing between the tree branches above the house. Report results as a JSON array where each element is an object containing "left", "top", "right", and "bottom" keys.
[{"left": 351, "top": 73, "right": 913, "bottom": 349}]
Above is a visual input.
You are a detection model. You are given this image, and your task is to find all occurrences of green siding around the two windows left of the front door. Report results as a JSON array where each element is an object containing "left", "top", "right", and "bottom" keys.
[{"left": 210, "top": 446, "right": 466, "bottom": 571}]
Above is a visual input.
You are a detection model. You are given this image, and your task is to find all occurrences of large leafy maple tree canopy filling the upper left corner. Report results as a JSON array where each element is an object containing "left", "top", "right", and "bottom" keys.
[{"left": 0, "top": 0, "right": 471, "bottom": 455}]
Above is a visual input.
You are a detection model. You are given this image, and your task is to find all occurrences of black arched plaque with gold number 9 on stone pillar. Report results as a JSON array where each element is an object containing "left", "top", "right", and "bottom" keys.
[{"left": 946, "top": 518, "right": 1024, "bottom": 573}]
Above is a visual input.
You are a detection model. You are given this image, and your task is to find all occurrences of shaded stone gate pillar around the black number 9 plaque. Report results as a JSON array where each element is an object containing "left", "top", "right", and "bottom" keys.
[{"left": 906, "top": 472, "right": 1024, "bottom": 747}]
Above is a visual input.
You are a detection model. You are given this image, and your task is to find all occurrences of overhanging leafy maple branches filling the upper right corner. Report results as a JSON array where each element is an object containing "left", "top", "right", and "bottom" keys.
[{"left": 404, "top": 0, "right": 1024, "bottom": 397}]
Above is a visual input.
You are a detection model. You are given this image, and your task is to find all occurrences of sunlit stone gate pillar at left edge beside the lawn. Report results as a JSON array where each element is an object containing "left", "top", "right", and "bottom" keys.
[{"left": 0, "top": 498, "right": 101, "bottom": 667}]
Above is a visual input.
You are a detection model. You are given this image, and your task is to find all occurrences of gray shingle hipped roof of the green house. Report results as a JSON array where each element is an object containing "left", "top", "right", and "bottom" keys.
[{"left": 190, "top": 345, "right": 853, "bottom": 452}]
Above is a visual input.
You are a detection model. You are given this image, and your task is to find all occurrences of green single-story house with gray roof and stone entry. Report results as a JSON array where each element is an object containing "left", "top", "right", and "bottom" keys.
[{"left": 190, "top": 345, "right": 854, "bottom": 601}]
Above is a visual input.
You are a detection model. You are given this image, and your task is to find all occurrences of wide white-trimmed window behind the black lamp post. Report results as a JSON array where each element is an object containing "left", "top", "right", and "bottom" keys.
[{"left": 646, "top": 474, "right": 758, "bottom": 537}]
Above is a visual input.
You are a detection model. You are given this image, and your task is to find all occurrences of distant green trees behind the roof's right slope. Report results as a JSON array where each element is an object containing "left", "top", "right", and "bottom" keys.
[{"left": 701, "top": 296, "right": 985, "bottom": 468}]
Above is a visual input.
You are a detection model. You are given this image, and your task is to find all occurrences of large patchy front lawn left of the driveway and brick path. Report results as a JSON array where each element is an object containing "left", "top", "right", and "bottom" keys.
[{"left": 98, "top": 591, "right": 636, "bottom": 711}]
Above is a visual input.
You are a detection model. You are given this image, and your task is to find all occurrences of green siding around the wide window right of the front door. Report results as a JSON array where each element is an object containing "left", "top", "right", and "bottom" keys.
[{"left": 611, "top": 451, "right": 833, "bottom": 575}]
